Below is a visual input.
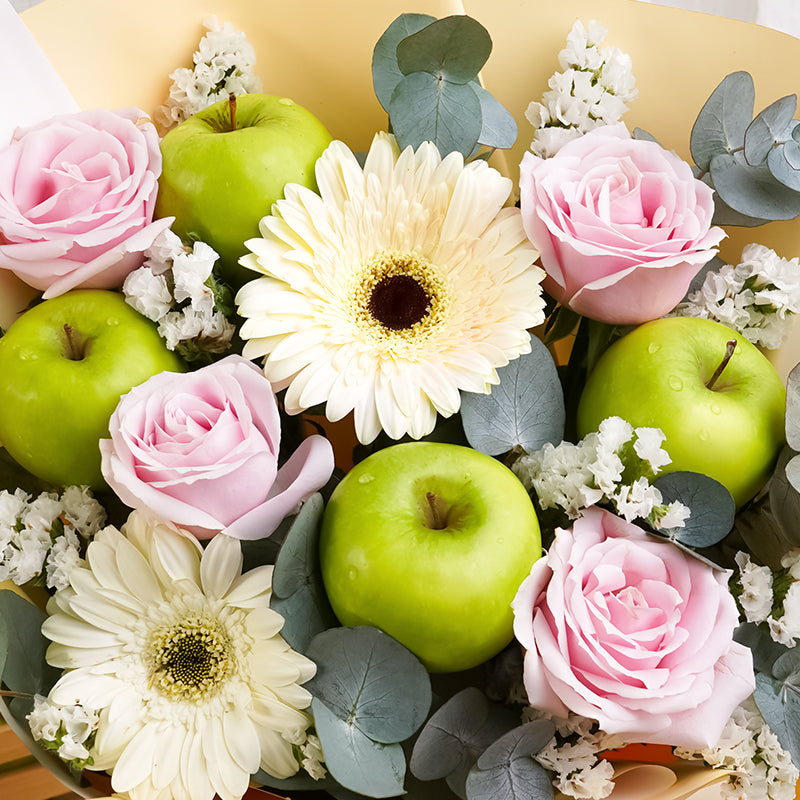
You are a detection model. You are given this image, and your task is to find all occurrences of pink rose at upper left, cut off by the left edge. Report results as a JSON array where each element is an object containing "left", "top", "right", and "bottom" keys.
[{"left": 0, "top": 108, "right": 172, "bottom": 298}]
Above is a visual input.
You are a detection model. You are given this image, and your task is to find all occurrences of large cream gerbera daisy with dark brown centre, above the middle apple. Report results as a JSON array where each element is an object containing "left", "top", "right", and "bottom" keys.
[{"left": 236, "top": 134, "right": 544, "bottom": 443}]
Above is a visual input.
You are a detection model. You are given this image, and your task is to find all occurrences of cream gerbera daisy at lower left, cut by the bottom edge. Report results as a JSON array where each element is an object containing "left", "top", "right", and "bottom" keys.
[{"left": 42, "top": 512, "right": 315, "bottom": 800}]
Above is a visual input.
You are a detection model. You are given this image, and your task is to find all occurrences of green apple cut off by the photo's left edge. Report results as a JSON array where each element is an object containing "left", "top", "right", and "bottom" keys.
[{"left": 0, "top": 289, "right": 185, "bottom": 489}]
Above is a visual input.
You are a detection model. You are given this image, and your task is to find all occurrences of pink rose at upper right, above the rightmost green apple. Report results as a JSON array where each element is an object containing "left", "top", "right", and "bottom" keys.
[{"left": 520, "top": 123, "right": 725, "bottom": 324}]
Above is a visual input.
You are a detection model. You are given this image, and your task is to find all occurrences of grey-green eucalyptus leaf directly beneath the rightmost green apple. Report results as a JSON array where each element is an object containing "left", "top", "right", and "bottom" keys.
[{"left": 653, "top": 471, "right": 736, "bottom": 547}]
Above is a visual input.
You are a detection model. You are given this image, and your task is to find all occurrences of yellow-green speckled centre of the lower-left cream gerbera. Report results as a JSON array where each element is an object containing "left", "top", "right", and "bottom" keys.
[{"left": 149, "top": 614, "right": 236, "bottom": 702}]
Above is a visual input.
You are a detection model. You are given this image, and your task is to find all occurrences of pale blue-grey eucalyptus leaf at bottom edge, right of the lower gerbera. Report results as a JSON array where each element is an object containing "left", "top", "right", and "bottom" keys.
[{"left": 311, "top": 697, "right": 406, "bottom": 797}]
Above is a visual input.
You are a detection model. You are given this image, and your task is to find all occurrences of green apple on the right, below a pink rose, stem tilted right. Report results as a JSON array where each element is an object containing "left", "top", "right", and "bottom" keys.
[{"left": 577, "top": 317, "right": 786, "bottom": 506}]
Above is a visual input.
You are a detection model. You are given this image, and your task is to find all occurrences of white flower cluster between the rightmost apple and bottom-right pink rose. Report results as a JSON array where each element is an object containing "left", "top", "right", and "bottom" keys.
[{"left": 513, "top": 417, "right": 689, "bottom": 529}]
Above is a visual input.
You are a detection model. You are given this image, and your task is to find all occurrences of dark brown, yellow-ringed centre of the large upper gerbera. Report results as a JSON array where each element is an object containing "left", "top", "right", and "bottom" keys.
[{"left": 349, "top": 250, "right": 449, "bottom": 344}]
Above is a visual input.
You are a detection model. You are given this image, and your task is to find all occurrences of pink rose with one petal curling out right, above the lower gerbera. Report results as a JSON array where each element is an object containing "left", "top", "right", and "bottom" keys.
[{"left": 100, "top": 355, "right": 333, "bottom": 539}]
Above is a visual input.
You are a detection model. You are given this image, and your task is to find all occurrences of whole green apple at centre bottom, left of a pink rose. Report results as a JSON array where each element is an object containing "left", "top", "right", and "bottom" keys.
[{"left": 320, "top": 442, "right": 542, "bottom": 672}]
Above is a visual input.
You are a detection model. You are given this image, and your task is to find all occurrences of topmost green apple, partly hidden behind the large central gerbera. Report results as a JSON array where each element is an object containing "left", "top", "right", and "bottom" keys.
[{"left": 155, "top": 94, "right": 331, "bottom": 288}]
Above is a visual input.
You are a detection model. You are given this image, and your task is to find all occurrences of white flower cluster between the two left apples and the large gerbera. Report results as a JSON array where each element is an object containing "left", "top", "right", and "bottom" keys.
[{"left": 122, "top": 230, "right": 236, "bottom": 362}]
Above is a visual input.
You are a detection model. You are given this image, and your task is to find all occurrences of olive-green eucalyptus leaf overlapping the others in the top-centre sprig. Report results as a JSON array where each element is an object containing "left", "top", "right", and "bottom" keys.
[{"left": 397, "top": 14, "right": 492, "bottom": 84}]
